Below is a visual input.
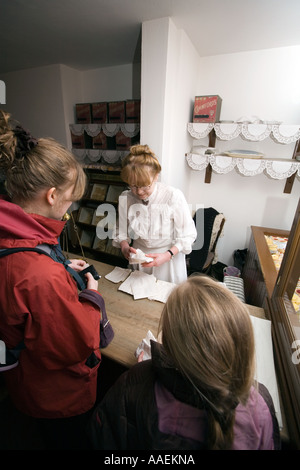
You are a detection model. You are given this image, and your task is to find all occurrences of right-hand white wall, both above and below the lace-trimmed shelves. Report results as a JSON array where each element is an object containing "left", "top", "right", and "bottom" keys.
[{"left": 188, "top": 46, "right": 300, "bottom": 264}]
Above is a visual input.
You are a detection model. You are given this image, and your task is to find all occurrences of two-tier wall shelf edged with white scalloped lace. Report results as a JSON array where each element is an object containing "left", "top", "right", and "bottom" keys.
[{"left": 186, "top": 123, "right": 300, "bottom": 193}]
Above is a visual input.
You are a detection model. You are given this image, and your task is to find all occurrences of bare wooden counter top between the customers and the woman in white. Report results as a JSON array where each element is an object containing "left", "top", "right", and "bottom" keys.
[{"left": 70, "top": 255, "right": 265, "bottom": 367}]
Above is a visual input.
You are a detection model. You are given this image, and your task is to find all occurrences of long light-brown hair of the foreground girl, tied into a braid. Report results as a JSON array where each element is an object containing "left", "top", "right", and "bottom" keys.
[{"left": 160, "top": 276, "right": 255, "bottom": 449}]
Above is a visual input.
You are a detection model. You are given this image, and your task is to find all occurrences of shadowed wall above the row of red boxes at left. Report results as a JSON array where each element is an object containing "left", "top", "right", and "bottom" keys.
[{"left": 1, "top": 64, "right": 140, "bottom": 148}]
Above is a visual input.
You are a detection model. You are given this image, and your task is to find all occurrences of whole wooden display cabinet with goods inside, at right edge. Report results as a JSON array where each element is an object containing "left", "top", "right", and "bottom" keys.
[{"left": 243, "top": 200, "right": 300, "bottom": 449}]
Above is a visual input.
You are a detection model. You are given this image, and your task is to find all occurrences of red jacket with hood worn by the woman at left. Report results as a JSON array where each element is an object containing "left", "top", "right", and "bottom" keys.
[{"left": 0, "top": 199, "right": 101, "bottom": 418}]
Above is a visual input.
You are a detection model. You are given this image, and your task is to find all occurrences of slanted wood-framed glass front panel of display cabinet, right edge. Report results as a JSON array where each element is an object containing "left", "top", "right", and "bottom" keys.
[{"left": 268, "top": 197, "right": 300, "bottom": 449}]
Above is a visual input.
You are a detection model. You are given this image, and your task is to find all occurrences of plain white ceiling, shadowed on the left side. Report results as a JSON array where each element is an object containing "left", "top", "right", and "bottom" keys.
[{"left": 0, "top": 0, "right": 300, "bottom": 73}]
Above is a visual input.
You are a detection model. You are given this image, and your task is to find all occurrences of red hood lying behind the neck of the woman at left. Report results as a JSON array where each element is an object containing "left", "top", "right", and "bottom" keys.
[{"left": 0, "top": 196, "right": 66, "bottom": 249}]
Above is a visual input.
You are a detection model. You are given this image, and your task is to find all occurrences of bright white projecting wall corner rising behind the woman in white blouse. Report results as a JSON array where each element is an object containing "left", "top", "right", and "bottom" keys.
[{"left": 141, "top": 18, "right": 199, "bottom": 195}]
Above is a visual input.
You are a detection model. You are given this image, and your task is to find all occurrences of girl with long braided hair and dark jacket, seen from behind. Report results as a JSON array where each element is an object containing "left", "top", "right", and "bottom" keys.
[{"left": 90, "top": 275, "right": 280, "bottom": 451}]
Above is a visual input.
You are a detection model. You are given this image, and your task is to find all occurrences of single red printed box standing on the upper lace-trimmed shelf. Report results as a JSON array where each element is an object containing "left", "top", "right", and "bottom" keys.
[{"left": 193, "top": 95, "right": 222, "bottom": 122}]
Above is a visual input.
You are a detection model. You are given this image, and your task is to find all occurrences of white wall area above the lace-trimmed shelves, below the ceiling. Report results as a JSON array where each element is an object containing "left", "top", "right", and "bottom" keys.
[{"left": 196, "top": 45, "right": 300, "bottom": 124}]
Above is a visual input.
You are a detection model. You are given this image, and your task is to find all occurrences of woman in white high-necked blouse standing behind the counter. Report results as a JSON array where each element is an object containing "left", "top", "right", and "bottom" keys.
[{"left": 113, "top": 145, "right": 197, "bottom": 284}]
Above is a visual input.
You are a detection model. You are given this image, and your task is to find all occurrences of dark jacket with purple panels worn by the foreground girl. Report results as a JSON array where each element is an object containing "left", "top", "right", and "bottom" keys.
[{"left": 89, "top": 343, "right": 280, "bottom": 450}]
